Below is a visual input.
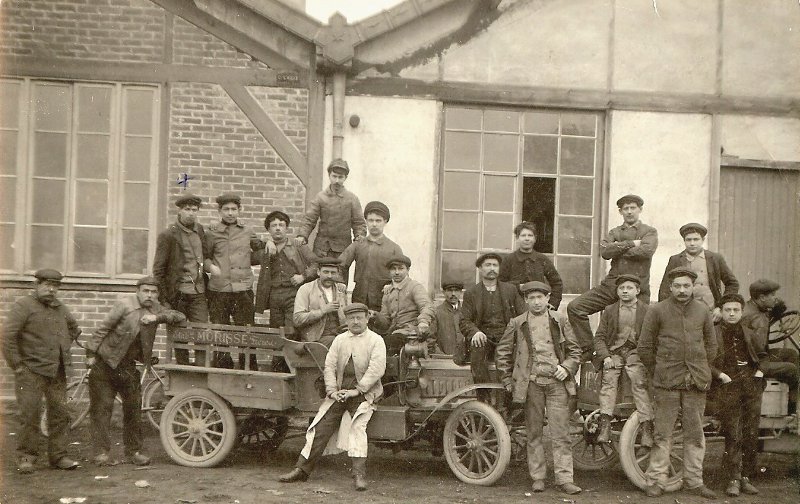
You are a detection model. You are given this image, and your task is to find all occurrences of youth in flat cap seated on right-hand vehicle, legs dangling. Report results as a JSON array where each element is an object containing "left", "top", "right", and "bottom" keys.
[{"left": 593, "top": 275, "right": 653, "bottom": 446}]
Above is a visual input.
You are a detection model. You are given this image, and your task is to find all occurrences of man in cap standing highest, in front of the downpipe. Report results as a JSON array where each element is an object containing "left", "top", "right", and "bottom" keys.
[{"left": 295, "top": 159, "right": 367, "bottom": 285}]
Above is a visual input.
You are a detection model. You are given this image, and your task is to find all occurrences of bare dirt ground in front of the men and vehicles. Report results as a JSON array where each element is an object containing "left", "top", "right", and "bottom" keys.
[{"left": 0, "top": 415, "right": 800, "bottom": 504}]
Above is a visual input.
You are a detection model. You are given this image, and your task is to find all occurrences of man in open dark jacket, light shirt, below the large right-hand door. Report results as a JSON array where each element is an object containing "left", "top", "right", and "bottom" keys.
[{"left": 658, "top": 222, "right": 739, "bottom": 324}]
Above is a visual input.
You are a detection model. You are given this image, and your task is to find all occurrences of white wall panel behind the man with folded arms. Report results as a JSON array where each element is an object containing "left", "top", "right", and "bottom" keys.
[{"left": 608, "top": 112, "right": 712, "bottom": 301}]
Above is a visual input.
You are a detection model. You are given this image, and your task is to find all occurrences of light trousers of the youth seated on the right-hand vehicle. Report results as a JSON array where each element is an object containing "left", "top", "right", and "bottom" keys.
[{"left": 600, "top": 349, "right": 653, "bottom": 421}]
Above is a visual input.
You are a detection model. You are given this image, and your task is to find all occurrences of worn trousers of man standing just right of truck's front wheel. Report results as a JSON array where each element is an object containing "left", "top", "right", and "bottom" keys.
[{"left": 525, "top": 381, "right": 573, "bottom": 485}]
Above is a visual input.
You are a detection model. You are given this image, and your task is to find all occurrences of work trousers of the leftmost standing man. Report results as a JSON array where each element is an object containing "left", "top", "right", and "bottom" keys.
[{"left": 14, "top": 364, "right": 71, "bottom": 464}]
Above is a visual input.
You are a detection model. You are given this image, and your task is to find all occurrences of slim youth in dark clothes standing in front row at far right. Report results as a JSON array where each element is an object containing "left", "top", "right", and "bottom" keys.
[{"left": 711, "top": 293, "right": 766, "bottom": 497}]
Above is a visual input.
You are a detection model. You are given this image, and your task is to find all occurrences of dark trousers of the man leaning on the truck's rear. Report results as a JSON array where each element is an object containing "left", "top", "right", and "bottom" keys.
[{"left": 89, "top": 357, "right": 142, "bottom": 455}]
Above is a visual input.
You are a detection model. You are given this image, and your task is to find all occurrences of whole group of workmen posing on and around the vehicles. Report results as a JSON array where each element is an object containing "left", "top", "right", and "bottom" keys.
[{"left": 3, "top": 159, "right": 798, "bottom": 498}]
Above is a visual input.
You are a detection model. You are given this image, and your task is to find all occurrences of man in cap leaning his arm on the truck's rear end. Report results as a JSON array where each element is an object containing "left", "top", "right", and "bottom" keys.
[{"left": 86, "top": 277, "right": 186, "bottom": 465}]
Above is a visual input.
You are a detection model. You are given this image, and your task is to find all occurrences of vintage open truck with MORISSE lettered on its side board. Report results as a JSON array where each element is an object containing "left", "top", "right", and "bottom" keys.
[{"left": 158, "top": 323, "right": 512, "bottom": 485}]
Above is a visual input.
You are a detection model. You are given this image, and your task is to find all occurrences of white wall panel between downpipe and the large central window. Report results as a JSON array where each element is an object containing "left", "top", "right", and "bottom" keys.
[{"left": 321, "top": 96, "right": 441, "bottom": 293}]
